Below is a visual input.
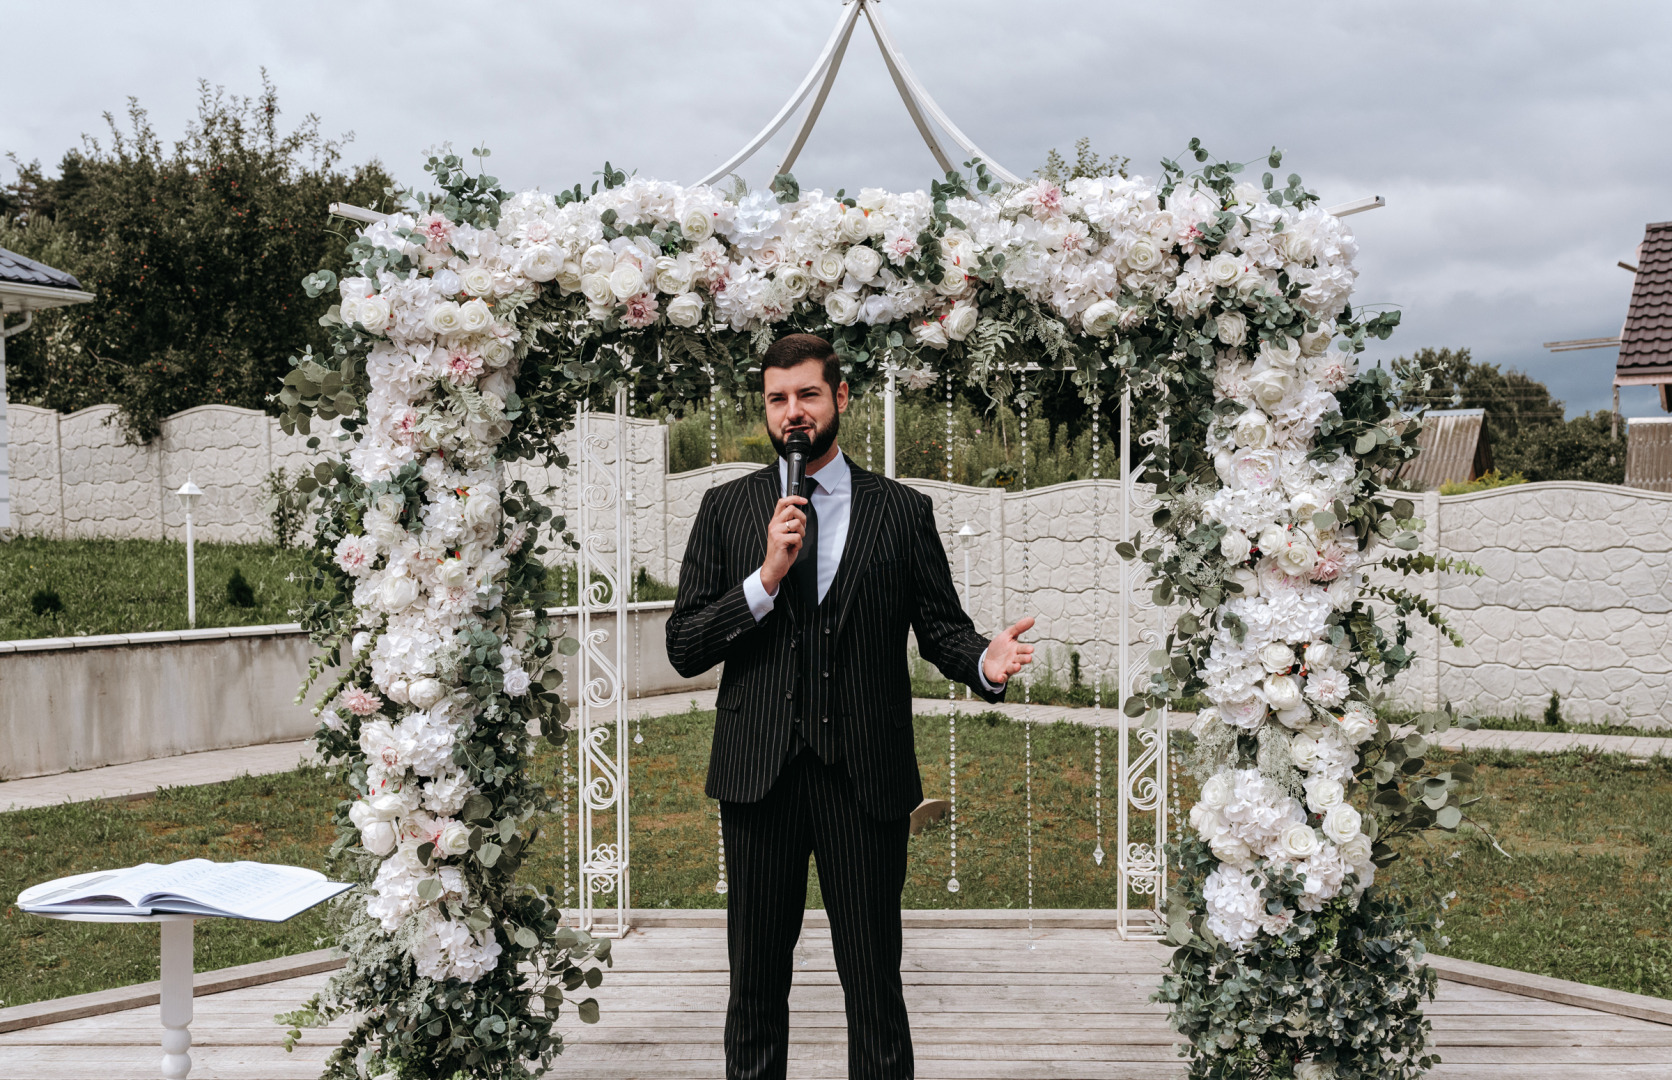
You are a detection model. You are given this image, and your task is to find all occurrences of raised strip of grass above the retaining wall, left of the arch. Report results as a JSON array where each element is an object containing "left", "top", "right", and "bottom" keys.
[{"left": 0, "top": 537, "right": 311, "bottom": 640}]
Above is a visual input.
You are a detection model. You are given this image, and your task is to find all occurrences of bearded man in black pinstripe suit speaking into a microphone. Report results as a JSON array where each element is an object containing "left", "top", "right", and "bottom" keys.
[{"left": 667, "top": 334, "right": 1033, "bottom": 1080}]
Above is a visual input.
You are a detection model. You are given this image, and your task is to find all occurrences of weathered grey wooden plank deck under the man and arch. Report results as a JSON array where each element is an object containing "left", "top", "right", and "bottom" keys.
[{"left": 0, "top": 913, "right": 1672, "bottom": 1080}]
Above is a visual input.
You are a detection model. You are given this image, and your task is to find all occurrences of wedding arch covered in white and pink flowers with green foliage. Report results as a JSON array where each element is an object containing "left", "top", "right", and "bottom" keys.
[{"left": 278, "top": 142, "right": 1478, "bottom": 1080}]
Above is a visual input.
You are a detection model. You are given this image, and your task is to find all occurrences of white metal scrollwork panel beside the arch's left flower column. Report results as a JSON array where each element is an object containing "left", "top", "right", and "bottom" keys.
[{"left": 575, "top": 390, "right": 632, "bottom": 938}]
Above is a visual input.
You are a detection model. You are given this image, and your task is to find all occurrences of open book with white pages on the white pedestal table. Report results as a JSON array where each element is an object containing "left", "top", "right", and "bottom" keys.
[{"left": 17, "top": 859, "right": 354, "bottom": 923}]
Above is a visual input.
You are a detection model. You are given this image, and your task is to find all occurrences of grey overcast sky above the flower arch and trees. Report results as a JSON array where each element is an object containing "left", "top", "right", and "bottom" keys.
[{"left": 0, "top": 0, "right": 1672, "bottom": 416}]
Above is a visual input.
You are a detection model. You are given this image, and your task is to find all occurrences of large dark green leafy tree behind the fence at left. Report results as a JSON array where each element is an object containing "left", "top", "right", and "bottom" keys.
[{"left": 0, "top": 72, "right": 390, "bottom": 440}]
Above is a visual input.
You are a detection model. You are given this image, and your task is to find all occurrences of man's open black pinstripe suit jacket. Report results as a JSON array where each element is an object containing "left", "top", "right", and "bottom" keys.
[{"left": 667, "top": 460, "right": 1003, "bottom": 819}]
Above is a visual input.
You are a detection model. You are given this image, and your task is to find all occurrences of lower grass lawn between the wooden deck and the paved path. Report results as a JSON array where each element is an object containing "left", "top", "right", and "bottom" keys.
[{"left": 0, "top": 712, "right": 1672, "bottom": 1005}]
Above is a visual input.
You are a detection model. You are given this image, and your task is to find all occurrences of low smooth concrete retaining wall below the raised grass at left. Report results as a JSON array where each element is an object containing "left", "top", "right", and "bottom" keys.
[{"left": 0, "top": 602, "right": 717, "bottom": 781}]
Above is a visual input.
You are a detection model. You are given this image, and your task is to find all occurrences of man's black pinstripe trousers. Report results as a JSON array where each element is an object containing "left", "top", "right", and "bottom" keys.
[{"left": 721, "top": 749, "right": 915, "bottom": 1080}]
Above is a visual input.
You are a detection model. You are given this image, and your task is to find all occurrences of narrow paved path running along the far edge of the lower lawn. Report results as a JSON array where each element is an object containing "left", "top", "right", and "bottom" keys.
[{"left": 0, "top": 690, "right": 1672, "bottom": 811}]
